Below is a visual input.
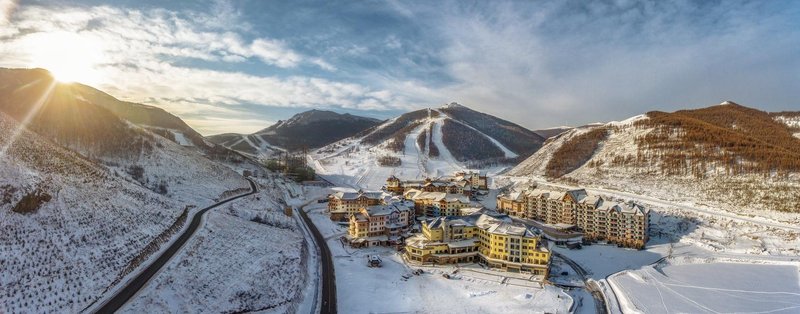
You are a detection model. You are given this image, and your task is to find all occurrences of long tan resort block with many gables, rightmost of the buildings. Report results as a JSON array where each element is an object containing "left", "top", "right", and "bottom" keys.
[{"left": 497, "top": 188, "right": 650, "bottom": 249}]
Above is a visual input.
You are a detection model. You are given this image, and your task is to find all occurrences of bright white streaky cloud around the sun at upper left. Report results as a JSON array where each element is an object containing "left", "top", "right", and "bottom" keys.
[{"left": 0, "top": 6, "right": 406, "bottom": 134}]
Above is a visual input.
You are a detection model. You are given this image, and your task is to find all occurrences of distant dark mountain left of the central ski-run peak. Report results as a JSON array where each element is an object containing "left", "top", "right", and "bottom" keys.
[{"left": 208, "top": 109, "right": 380, "bottom": 156}]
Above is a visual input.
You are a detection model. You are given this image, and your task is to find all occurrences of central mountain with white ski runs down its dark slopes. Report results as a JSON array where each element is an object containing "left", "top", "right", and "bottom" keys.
[{"left": 310, "top": 103, "right": 544, "bottom": 189}]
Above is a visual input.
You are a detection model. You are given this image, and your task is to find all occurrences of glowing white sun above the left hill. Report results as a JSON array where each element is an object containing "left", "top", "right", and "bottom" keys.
[{"left": 26, "top": 32, "right": 104, "bottom": 85}]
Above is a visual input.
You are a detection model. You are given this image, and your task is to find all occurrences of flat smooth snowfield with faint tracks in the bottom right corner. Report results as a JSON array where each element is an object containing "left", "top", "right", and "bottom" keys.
[{"left": 609, "top": 260, "right": 800, "bottom": 313}]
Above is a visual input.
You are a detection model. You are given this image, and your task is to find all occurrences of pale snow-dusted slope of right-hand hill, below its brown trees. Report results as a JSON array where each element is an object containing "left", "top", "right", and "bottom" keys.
[{"left": 508, "top": 103, "right": 800, "bottom": 216}]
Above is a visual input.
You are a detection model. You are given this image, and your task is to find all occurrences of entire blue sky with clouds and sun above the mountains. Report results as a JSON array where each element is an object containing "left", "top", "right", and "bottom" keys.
[{"left": 0, "top": 0, "right": 800, "bottom": 135}]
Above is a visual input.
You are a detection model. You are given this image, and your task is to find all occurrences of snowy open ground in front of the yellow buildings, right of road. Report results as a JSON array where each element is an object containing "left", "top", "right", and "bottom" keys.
[{"left": 306, "top": 203, "right": 573, "bottom": 313}]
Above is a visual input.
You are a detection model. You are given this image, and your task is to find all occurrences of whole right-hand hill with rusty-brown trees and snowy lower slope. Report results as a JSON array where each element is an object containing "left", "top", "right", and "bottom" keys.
[{"left": 508, "top": 102, "right": 800, "bottom": 214}]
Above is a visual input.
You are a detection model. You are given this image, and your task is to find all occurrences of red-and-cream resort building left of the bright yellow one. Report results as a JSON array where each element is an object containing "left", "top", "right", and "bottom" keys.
[{"left": 348, "top": 201, "right": 414, "bottom": 247}]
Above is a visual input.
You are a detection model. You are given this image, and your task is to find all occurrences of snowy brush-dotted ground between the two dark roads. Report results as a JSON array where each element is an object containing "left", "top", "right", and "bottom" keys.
[{"left": 123, "top": 185, "right": 307, "bottom": 313}]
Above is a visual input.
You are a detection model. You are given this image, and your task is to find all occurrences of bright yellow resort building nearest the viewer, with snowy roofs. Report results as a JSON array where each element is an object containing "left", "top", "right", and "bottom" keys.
[{"left": 405, "top": 209, "right": 550, "bottom": 279}]
